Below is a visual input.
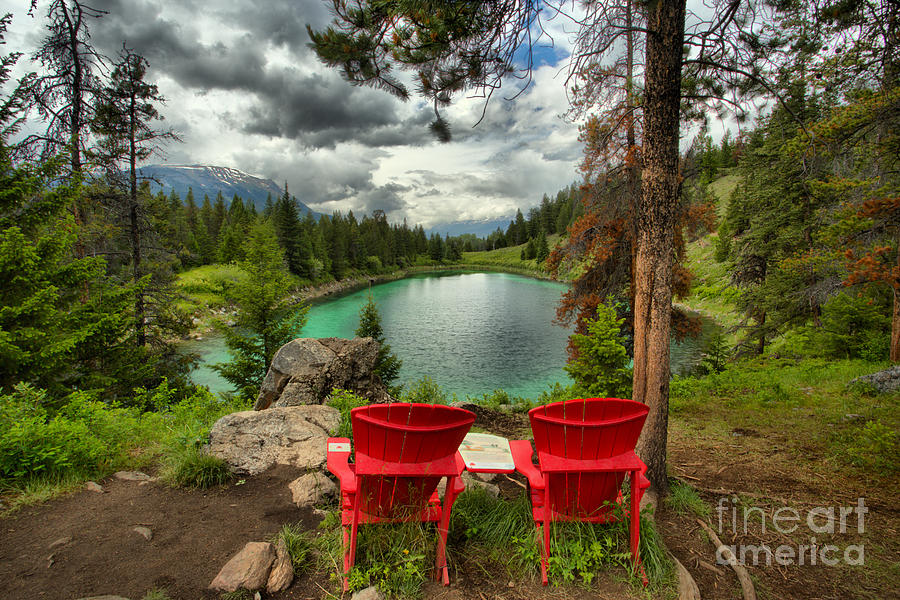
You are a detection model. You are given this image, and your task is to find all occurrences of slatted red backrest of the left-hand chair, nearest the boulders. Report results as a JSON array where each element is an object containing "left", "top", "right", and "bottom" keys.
[{"left": 350, "top": 403, "right": 475, "bottom": 518}]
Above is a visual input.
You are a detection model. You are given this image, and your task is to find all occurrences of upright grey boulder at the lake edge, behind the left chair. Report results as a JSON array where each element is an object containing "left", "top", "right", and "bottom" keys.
[{"left": 253, "top": 338, "right": 392, "bottom": 410}]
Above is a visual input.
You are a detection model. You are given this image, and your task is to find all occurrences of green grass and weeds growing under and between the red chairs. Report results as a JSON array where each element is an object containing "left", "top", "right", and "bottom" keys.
[{"left": 299, "top": 488, "right": 674, "bottom": 598}]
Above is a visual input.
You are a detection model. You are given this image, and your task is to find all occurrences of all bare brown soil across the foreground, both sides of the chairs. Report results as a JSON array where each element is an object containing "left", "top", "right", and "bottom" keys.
[{"left": 0, "top": 408, "right": 900, "bottom": 600}]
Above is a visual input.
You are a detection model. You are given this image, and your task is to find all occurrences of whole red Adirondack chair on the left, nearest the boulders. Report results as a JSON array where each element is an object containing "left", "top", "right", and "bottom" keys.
[{"left": 327, "top": 403, "right": 475, "bottom": 591}]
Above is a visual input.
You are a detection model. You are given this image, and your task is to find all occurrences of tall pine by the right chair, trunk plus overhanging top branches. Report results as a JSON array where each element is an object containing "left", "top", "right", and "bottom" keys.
[{"left": 308, "top": 0, "right": 800, "bottom": 494}]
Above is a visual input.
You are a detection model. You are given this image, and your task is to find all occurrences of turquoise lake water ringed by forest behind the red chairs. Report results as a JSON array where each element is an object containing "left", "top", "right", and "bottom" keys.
[{"left": 183, "top": 272, "right": 571, "bottom": 399}]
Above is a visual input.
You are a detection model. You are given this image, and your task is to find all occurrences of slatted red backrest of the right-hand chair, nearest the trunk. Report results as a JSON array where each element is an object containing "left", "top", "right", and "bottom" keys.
[{"left": 528, "top": 398, "right": 649, "bottom": 518}]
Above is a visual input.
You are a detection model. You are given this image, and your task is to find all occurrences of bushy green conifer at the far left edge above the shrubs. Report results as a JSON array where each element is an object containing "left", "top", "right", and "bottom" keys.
[{"left": 0, "top": 22, "right": 164, "bottom": 401}]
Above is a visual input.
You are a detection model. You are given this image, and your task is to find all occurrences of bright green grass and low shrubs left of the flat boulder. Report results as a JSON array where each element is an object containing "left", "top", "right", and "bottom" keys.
[{"left": 0, "top": 382, "right": 247, "bottom": 512}]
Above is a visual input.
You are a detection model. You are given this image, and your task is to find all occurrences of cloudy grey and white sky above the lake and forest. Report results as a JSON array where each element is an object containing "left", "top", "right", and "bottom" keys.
[{"left": 0, "top": 0, "right": 581, "bottom": 227}]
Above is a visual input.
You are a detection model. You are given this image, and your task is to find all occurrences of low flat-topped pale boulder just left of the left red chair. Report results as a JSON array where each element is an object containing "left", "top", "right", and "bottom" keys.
[{"left": 207, "top": 405, "right": 341, "bottom": 475}]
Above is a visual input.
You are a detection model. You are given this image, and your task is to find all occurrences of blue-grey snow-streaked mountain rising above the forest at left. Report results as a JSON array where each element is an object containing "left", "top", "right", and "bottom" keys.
[{"left": 138, "top": 165, "right": 321, "bottom": 219}]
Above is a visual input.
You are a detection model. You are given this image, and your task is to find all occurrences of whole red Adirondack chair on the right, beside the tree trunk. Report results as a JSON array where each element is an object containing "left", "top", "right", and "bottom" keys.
[{"left": 509, "top": 398, "right": 650, "bottom": 585}]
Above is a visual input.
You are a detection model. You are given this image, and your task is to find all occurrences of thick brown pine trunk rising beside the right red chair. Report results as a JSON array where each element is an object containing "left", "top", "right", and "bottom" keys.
[{"left": 634, "top": 0, "right": 685, "bottom": 494}]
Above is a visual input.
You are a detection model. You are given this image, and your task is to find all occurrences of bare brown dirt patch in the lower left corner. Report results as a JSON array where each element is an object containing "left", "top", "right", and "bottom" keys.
[{"left": 0, "top": 468, "right": 319, "bottom": 600}]
